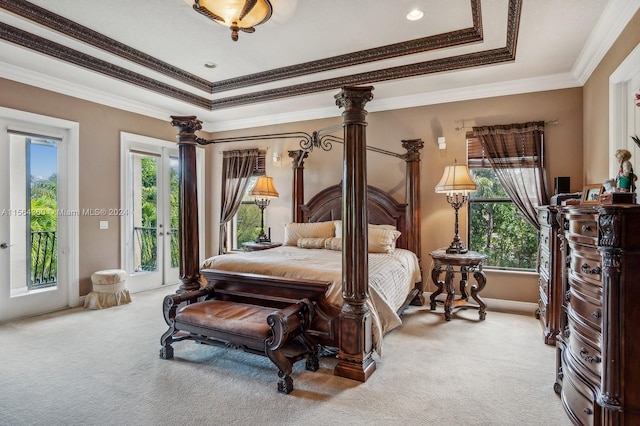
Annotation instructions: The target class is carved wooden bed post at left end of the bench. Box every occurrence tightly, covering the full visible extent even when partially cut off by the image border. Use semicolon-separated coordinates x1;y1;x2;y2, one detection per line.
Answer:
171;115;202;293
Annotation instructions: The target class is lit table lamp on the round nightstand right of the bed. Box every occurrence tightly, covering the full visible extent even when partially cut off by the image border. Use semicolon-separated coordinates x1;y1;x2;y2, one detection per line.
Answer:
436;161;478;253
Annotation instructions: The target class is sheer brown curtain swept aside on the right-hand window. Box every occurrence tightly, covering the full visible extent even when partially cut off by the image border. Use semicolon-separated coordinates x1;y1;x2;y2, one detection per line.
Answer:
469;121;549;230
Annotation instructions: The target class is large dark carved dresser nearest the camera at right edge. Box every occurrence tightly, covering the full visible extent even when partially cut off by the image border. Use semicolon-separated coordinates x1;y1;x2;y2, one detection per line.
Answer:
555;204;640;425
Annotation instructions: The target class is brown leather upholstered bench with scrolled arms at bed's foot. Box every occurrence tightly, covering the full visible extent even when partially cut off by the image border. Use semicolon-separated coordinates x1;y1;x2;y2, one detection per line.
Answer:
160;290;319;394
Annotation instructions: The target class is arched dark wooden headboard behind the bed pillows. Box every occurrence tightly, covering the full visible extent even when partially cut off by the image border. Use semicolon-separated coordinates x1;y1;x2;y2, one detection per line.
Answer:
301;184;411;249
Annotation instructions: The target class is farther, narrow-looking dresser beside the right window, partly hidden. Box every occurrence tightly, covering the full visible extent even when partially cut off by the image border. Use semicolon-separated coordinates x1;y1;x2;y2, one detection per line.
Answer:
536;205;564;345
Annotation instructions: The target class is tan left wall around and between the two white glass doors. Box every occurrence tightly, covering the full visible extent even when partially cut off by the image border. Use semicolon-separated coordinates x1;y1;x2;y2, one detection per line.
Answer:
0;79;176;295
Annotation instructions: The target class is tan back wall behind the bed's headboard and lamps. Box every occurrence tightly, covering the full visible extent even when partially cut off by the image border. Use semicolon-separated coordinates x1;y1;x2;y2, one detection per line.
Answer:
207;88;582;302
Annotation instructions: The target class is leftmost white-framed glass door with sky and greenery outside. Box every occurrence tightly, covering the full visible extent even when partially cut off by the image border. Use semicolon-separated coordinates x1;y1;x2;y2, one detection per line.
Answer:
0;109;79;321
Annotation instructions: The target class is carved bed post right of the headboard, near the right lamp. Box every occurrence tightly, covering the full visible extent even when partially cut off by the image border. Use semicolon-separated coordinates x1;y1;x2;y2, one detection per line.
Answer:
402;139;424;306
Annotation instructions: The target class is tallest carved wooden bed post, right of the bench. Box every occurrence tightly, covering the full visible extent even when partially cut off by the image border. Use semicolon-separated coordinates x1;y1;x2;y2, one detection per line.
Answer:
334;86;376;382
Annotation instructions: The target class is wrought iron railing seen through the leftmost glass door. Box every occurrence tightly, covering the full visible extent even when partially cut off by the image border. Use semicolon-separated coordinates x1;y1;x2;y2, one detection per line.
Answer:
31;231;58;288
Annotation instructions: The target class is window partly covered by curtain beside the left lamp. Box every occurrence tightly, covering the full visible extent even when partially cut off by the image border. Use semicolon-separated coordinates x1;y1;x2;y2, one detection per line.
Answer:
227;151;266;250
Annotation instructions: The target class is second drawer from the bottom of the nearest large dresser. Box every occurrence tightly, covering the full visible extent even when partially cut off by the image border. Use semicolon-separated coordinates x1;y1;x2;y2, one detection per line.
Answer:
565;310;602;378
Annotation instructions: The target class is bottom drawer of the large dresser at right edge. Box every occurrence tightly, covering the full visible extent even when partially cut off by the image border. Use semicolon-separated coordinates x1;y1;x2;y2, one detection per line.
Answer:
562;350;597;425
